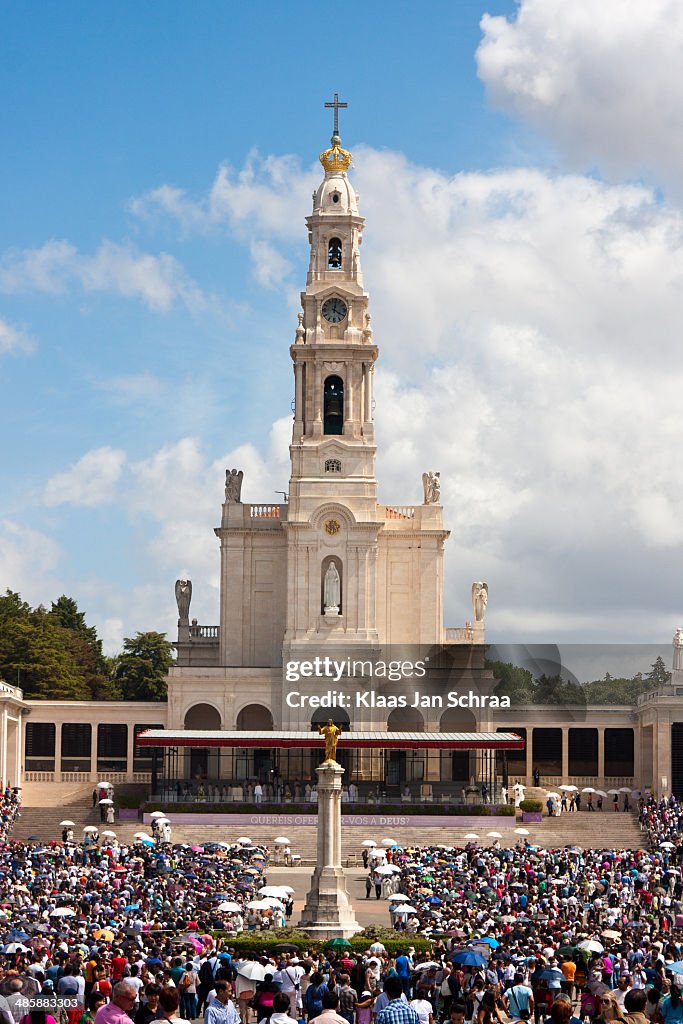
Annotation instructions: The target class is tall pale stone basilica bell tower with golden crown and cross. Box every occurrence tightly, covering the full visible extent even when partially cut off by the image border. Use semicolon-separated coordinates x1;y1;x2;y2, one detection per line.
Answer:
283;108;381;642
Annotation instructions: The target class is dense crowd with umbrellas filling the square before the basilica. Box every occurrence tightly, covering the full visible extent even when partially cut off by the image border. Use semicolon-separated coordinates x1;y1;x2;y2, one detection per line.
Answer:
0;792;683;1024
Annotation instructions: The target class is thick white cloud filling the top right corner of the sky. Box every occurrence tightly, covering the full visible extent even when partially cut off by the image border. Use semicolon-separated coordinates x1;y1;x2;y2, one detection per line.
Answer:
477;0;683;195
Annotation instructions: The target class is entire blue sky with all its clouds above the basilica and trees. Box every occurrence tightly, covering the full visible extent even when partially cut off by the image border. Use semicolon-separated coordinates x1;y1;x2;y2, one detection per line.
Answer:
0;0;683;649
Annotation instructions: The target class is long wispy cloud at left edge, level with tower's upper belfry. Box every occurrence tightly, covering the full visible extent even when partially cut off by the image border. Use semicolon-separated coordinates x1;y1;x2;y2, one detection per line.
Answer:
0;240;206;312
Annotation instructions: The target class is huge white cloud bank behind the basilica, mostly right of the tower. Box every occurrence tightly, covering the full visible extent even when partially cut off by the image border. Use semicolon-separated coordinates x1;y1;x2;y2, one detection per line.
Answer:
28;150;683;640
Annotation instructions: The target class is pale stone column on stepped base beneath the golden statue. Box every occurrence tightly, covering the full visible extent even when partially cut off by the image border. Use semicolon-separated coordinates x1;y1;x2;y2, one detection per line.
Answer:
300;761;360;939
